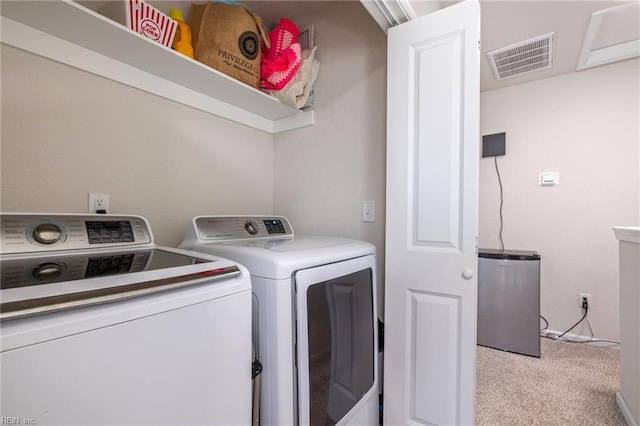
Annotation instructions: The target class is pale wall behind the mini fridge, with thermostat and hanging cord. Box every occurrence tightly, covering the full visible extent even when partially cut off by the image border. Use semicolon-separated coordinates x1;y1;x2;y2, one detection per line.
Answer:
479;59;640;340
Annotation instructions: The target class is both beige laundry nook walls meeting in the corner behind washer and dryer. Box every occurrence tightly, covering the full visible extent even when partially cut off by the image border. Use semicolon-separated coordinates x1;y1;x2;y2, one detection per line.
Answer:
0;2;386;314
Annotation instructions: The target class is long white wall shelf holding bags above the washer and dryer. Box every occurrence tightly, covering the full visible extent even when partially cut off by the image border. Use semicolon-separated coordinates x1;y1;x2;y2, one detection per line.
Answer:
0;0;314;134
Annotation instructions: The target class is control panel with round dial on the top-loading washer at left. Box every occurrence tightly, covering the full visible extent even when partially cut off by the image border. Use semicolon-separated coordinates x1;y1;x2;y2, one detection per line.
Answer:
0;213;153;254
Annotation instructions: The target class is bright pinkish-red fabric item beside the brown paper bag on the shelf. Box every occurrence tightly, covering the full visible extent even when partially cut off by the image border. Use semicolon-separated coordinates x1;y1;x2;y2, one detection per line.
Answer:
260;18;302;90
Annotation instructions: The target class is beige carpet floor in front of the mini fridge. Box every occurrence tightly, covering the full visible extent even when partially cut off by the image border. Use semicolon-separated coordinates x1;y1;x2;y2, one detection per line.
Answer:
476;338;626;426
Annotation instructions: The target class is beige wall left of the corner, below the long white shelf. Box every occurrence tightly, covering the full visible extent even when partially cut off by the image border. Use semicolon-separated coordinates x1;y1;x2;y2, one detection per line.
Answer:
0;45;273;246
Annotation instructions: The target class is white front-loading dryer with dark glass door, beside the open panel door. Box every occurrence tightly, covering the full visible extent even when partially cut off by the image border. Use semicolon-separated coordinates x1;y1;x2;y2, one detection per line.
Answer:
180;216;379;426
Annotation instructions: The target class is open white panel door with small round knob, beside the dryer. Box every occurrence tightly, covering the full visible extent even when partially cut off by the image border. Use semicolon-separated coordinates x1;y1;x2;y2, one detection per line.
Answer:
384;1;480;425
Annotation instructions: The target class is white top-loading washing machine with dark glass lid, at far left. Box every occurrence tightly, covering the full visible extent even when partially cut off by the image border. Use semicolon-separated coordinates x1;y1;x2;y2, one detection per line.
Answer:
0;213;253;425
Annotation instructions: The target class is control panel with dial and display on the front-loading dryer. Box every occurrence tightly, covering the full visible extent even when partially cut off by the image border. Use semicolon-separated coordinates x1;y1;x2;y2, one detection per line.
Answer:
194;216;293;241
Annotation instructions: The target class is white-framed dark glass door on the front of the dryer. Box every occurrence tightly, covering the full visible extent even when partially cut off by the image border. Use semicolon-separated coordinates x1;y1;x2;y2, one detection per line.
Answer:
295;256;378;425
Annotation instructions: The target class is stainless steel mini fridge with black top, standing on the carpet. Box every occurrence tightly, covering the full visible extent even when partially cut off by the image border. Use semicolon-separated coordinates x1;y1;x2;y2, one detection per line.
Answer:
478;249;540;357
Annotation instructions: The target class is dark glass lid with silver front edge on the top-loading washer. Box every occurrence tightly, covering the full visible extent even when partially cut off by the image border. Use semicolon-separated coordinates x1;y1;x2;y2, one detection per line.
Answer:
0;248;242;319
